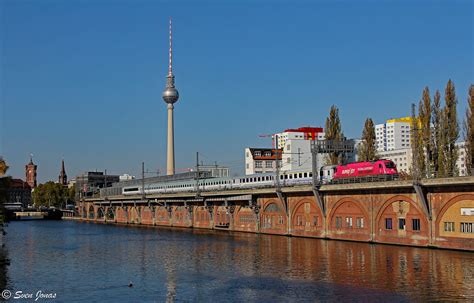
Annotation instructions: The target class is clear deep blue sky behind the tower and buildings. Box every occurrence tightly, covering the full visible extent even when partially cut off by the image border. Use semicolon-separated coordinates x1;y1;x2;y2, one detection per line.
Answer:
0;0;474;182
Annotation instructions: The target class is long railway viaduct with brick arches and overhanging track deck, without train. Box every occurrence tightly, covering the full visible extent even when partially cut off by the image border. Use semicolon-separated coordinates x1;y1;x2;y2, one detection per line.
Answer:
78;177;474;251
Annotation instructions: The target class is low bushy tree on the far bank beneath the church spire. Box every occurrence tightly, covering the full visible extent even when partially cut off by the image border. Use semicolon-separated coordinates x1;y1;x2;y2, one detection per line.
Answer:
33;181;70;208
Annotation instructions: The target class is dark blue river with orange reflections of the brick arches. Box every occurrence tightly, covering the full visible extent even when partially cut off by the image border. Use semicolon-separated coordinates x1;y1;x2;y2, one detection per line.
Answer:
0;221;474;302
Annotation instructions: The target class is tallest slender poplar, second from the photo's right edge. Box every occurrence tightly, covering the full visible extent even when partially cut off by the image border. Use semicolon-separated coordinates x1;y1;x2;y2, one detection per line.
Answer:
444;79;459;175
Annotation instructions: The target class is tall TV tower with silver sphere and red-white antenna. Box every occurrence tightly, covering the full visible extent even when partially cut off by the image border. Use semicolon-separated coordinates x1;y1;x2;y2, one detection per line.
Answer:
163;17;179;175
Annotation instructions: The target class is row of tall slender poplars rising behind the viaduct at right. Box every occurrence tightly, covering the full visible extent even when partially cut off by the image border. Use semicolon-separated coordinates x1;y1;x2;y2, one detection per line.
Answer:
325;80;474;177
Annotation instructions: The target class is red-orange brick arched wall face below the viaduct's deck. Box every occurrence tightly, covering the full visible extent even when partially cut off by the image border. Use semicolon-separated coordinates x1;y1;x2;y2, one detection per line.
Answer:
79;187;474;251
